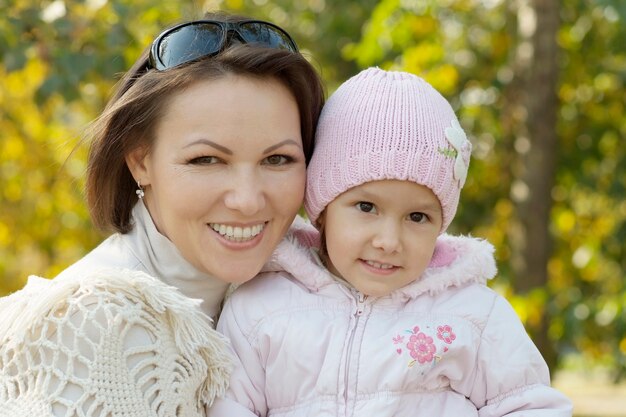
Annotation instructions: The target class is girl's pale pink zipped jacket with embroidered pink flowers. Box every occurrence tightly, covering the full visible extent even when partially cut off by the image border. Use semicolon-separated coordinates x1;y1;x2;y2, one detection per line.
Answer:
209;235;572;417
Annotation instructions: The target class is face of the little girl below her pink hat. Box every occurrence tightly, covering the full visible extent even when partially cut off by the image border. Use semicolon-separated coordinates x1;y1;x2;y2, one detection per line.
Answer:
323;180;442;297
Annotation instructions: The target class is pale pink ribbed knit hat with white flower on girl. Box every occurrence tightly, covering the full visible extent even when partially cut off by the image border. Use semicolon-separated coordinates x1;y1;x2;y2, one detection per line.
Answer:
304;68;471;233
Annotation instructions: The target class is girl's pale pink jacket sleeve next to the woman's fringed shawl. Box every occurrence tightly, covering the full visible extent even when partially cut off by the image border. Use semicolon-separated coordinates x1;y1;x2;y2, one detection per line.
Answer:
208;293;268;417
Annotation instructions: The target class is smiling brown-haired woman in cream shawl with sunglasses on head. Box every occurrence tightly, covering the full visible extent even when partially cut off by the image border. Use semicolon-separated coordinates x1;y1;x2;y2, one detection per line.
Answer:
0;15;323;416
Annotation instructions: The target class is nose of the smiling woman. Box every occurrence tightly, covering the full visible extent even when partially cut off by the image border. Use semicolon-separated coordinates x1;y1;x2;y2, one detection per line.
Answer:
224;171;265;216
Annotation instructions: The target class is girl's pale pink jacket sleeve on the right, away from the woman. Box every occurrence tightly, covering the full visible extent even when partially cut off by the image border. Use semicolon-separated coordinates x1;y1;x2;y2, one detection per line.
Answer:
470;296;572;417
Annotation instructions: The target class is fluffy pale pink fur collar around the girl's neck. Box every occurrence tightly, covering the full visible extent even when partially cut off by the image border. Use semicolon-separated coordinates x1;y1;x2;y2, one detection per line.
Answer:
264;230;497;299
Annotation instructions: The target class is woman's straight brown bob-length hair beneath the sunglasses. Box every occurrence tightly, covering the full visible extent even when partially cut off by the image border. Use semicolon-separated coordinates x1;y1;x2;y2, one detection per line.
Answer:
86;15;324;233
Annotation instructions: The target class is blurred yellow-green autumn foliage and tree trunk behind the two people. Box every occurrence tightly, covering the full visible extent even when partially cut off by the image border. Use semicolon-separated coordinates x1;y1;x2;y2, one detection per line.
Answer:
0;0;626;416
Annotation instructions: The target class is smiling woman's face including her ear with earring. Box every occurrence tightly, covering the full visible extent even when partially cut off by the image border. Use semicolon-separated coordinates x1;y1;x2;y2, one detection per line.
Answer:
127;75;306;283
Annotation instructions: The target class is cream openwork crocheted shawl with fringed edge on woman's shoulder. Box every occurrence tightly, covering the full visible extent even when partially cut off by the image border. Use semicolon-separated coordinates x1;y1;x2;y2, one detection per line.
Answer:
0;270;232;417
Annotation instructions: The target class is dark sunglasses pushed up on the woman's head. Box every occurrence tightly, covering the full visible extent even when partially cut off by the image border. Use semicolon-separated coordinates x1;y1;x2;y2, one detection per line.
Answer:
148;20;298;71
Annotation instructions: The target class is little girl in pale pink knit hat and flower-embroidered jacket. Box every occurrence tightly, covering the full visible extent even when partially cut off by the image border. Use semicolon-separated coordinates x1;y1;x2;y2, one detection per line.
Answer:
209;68;572;417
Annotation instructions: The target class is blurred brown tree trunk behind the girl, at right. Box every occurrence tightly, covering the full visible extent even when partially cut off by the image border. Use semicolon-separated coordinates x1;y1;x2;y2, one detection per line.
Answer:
515;0;560;366
